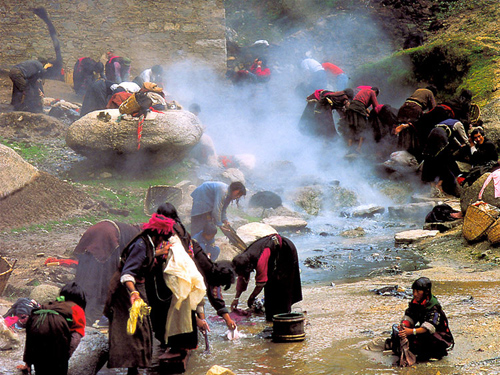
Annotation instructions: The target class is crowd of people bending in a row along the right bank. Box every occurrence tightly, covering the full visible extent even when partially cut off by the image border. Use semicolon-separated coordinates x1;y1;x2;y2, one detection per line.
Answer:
299;79;499;197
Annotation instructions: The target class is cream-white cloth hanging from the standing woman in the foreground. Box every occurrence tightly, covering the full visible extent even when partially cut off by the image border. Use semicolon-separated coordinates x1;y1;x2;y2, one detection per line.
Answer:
163;235;206;342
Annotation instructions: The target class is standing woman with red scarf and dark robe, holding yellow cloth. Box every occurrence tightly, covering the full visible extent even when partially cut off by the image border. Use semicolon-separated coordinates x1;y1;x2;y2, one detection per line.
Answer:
104;214;175;375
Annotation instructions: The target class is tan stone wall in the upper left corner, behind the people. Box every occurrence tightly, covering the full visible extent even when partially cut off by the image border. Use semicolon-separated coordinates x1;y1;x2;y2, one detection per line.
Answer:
0;0;226;76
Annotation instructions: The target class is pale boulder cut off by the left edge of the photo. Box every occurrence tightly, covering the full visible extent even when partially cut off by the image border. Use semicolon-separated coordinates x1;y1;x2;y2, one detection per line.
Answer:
0;144;38;198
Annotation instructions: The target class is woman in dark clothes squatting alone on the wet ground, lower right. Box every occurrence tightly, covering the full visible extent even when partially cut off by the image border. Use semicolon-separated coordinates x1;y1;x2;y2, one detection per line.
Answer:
391;277;455;366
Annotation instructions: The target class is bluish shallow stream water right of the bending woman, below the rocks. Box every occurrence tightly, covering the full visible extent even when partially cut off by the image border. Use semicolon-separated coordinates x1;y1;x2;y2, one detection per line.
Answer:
290;215;428;285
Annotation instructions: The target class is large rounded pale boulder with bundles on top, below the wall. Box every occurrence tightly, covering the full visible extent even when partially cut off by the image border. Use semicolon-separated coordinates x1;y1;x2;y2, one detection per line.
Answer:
66;109;203;163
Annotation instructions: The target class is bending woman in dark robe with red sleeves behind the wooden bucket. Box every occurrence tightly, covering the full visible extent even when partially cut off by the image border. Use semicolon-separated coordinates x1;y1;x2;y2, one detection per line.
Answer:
231;234;302;321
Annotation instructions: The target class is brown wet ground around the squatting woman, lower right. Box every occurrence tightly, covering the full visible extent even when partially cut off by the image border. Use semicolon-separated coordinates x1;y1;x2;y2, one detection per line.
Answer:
90;262;500;375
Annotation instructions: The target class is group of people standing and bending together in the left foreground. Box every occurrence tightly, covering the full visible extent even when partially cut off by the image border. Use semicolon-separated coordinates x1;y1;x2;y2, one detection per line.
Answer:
15;181;302;374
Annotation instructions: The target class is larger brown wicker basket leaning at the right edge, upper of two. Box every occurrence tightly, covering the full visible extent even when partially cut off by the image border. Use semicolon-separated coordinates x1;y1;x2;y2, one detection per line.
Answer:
462;201;500;241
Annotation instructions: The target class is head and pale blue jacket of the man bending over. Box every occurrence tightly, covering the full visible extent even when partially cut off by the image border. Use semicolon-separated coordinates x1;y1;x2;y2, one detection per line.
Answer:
191;181;247;234
